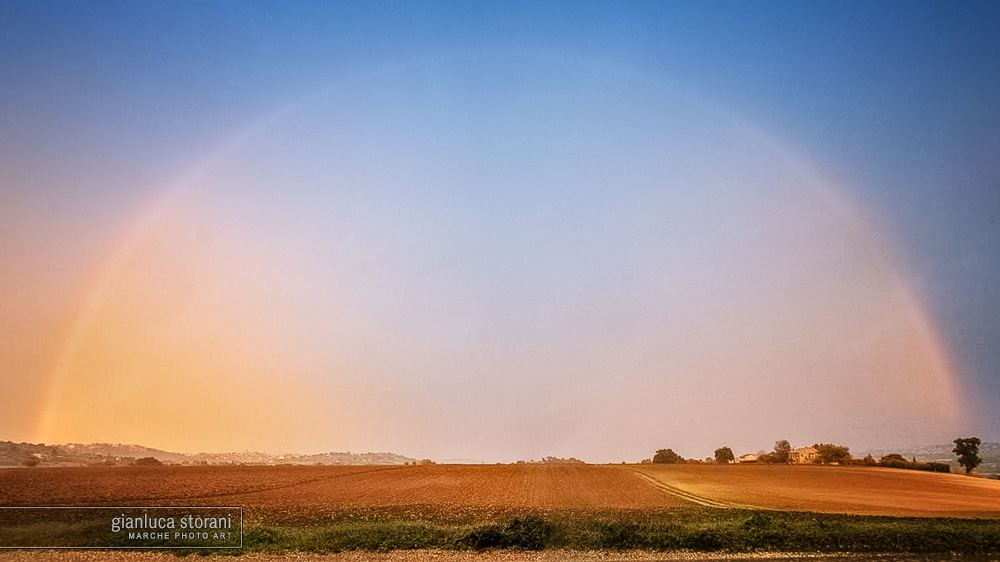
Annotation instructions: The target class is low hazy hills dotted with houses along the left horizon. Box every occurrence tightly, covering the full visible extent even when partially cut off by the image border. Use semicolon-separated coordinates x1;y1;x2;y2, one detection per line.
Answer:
0;441;416;467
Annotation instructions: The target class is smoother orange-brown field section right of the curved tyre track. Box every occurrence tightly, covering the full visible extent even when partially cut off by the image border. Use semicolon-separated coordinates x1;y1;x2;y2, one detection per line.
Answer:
633;465;1000;519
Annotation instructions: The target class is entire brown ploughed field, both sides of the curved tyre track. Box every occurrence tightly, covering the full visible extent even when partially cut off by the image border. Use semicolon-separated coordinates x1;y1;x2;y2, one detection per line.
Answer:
0;464;1000;518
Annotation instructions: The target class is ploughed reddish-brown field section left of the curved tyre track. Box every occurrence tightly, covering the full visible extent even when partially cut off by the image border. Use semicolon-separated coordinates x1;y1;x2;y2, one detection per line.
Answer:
0;464;689;515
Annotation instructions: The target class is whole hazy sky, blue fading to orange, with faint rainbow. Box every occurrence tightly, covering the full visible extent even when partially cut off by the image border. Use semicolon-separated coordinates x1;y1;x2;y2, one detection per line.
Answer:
0;1;1000;461
